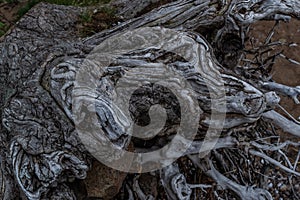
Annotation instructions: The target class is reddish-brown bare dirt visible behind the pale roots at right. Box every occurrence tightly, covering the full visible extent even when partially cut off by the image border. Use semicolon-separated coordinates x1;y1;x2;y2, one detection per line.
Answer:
249;19;300;139
